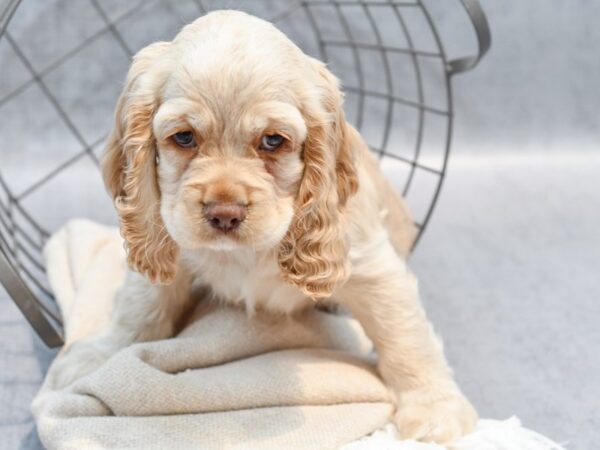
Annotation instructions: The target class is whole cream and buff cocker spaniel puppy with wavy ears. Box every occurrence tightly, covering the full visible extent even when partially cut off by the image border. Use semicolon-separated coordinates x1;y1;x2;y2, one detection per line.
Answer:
59;11;477;443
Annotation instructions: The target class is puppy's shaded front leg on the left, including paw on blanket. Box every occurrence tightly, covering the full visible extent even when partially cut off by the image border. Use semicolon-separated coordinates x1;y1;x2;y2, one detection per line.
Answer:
51;271;190;388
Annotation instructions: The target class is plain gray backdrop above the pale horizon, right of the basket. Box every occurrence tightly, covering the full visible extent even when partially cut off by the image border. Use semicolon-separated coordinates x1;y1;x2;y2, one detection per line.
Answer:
428;0;600;153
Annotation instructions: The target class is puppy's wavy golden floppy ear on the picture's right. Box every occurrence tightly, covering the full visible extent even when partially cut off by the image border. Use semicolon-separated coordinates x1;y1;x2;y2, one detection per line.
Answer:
279;59;358;299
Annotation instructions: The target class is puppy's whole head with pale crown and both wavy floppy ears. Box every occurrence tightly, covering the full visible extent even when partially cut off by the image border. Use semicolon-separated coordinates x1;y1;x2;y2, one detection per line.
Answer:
103;12;357;297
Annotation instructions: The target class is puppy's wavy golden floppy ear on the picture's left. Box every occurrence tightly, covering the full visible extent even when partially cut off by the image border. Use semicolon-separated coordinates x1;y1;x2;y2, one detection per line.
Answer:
102;42;179;283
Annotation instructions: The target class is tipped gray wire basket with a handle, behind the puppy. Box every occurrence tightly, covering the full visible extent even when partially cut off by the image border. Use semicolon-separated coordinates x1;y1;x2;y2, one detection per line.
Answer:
0;0;490;347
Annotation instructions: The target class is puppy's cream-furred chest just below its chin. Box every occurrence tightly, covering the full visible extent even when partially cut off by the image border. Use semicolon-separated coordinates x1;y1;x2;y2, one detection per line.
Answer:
188;252;311;314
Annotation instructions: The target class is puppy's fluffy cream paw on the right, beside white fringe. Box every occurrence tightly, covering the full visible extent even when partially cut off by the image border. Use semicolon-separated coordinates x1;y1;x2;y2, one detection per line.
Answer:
395;387;477;445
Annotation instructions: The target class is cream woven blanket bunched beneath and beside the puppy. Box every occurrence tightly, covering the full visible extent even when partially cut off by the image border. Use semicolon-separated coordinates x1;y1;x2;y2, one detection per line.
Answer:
33;221;558;450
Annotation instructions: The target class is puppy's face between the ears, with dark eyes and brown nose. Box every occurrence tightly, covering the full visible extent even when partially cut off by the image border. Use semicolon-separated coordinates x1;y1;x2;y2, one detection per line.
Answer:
152;80;307;250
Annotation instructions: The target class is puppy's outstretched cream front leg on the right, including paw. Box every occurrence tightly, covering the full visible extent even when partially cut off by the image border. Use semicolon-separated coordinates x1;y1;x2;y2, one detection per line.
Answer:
336;240;477;444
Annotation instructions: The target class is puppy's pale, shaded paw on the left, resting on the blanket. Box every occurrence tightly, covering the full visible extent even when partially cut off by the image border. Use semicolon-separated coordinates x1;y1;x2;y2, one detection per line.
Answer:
50;340;111;389
